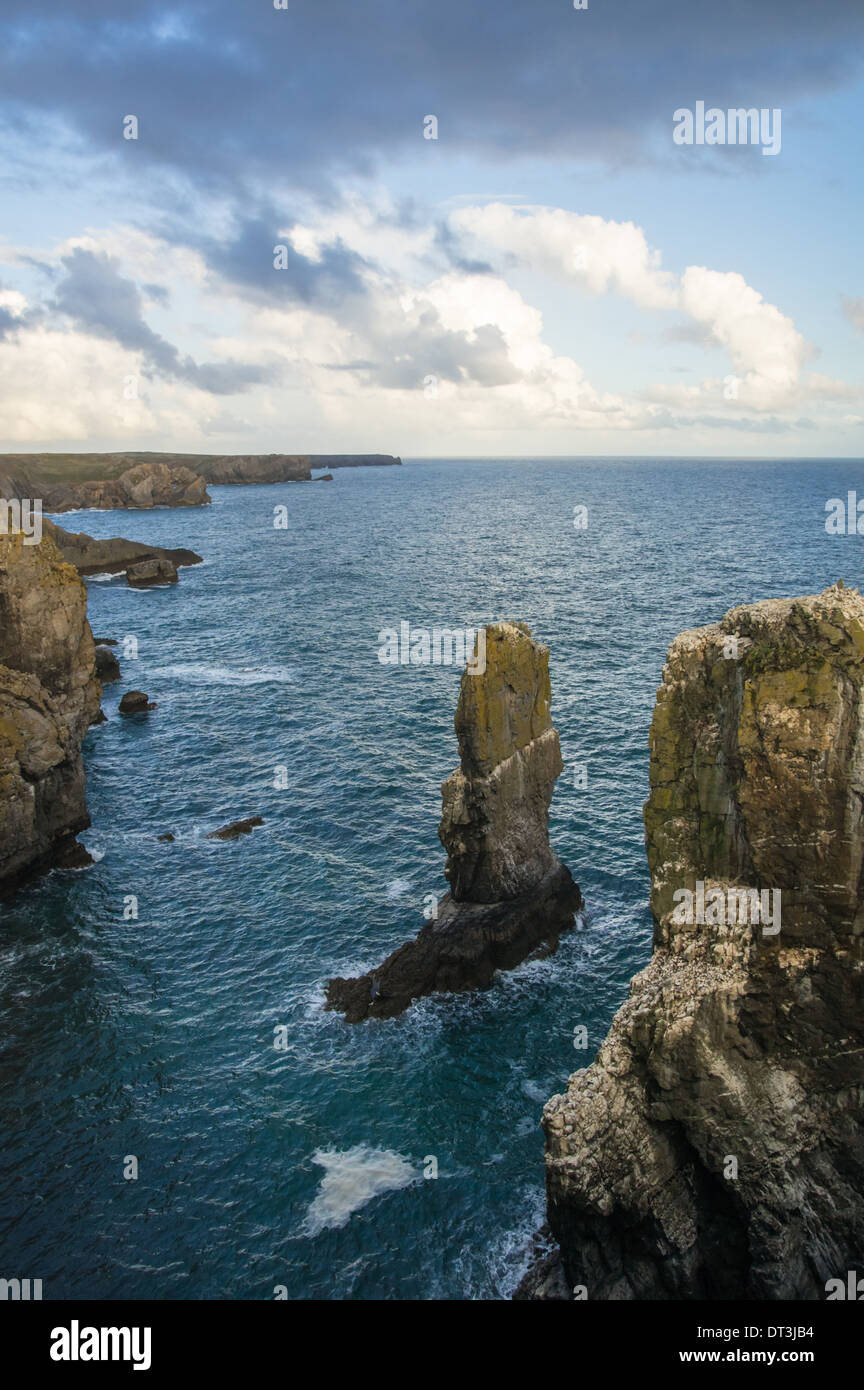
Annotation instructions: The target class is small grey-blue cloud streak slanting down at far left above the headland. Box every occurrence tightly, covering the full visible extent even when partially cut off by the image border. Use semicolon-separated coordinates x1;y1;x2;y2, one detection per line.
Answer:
51;247;269;396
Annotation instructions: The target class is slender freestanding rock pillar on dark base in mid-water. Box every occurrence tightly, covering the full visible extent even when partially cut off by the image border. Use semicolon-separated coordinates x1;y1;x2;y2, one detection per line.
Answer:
326;623;582;1023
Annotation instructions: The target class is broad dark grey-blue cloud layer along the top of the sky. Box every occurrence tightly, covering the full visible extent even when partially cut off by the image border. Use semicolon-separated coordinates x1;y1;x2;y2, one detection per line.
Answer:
0;0;864;197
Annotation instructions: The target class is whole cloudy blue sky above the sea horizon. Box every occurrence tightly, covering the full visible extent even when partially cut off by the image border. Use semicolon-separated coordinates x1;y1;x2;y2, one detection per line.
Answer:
0;0;864;459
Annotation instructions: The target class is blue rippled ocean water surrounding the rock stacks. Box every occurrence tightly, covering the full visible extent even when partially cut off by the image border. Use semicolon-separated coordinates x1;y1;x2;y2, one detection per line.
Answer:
0;460;861;1300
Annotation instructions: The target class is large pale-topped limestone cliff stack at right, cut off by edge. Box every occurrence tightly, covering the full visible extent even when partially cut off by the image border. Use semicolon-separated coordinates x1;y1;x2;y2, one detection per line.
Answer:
517;585;864;1300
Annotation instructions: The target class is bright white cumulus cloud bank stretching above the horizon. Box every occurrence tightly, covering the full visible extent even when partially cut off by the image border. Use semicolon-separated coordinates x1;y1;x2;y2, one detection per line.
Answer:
0;211;861;453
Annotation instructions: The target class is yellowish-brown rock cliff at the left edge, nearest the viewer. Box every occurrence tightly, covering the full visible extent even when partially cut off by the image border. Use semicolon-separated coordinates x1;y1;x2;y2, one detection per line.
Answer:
0;535;101;892
